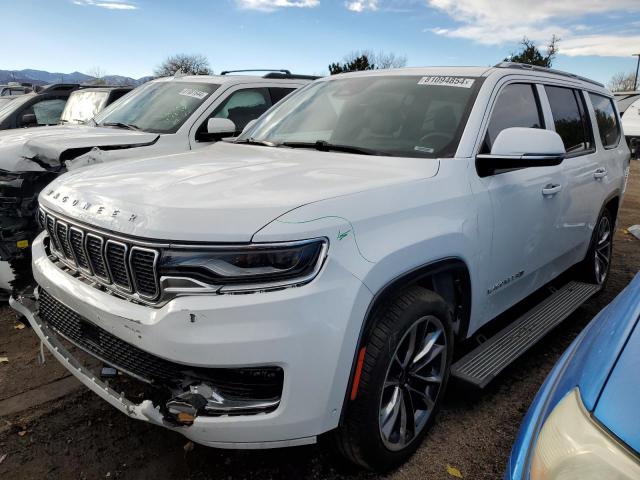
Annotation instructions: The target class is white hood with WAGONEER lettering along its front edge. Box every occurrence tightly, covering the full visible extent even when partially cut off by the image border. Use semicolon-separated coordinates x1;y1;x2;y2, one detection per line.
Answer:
40;142;439;242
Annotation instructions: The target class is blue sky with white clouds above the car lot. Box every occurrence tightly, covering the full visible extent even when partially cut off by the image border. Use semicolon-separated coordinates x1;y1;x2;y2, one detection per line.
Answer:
0;0;640;83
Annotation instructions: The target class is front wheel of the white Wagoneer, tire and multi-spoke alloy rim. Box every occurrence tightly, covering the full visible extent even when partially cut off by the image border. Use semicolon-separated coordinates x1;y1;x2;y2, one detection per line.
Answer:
336;286;453;471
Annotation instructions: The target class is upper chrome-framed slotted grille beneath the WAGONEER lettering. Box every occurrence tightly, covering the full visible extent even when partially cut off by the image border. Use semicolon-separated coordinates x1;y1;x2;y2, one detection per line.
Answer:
38;209;160;302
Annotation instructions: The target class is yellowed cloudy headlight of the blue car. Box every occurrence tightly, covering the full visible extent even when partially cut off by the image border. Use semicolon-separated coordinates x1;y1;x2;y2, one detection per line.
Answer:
530;388;640;480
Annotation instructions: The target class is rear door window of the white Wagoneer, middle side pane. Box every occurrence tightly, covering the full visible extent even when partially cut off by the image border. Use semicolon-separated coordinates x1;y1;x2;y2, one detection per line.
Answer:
544;86;594;154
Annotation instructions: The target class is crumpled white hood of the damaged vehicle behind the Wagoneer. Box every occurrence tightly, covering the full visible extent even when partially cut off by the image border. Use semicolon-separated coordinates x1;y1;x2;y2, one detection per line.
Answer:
0;125;159;172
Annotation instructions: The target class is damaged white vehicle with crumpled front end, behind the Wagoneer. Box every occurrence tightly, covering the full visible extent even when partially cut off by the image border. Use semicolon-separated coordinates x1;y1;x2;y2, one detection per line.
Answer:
0;70;314;294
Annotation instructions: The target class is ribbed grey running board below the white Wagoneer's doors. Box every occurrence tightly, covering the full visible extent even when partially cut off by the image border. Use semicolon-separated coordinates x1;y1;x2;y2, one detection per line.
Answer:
451;281;600;388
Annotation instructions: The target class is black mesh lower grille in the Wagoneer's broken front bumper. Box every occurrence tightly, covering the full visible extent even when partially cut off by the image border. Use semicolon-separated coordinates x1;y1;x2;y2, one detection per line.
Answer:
38;289;284;400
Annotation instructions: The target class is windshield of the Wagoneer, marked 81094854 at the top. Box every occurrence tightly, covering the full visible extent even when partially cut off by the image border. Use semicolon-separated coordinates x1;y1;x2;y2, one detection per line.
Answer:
238;75;480;158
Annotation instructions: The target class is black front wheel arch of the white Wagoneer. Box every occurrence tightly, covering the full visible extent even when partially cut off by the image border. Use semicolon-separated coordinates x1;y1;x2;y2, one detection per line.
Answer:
340;257;472;424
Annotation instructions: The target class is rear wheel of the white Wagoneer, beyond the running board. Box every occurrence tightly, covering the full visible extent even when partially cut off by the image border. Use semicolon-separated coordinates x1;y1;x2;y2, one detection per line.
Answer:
578;208;615;288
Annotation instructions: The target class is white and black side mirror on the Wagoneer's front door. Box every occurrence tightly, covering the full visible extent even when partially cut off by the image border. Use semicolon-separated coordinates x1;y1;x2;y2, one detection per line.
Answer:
476;127;566;177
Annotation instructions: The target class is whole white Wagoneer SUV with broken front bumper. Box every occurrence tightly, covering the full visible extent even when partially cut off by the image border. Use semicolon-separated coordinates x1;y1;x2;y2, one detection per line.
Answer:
11;63;629;470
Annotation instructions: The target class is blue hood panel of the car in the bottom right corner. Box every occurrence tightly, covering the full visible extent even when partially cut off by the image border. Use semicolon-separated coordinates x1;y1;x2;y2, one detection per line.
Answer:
594;312;640;452
